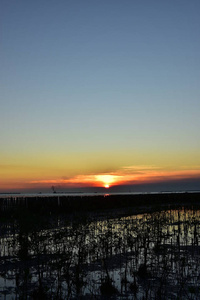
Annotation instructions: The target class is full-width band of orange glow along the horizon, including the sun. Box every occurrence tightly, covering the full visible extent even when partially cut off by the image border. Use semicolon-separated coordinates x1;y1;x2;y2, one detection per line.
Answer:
1;166;200;191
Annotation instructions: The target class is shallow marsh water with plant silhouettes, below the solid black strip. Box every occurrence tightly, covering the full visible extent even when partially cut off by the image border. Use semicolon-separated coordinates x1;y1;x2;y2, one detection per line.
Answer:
0;208;200;299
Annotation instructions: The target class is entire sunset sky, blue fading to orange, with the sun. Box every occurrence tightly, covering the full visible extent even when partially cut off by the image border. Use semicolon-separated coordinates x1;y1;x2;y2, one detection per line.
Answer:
0;0;200;192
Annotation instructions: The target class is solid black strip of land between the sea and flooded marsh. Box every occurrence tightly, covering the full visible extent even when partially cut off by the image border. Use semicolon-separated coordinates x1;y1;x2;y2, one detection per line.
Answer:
0;191;200;215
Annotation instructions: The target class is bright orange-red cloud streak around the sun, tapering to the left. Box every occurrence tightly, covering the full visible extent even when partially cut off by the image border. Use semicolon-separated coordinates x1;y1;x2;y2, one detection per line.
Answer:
29;166;200;187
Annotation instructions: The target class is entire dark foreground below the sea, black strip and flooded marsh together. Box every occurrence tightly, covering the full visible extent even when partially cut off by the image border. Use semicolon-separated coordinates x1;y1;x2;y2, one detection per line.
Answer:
0;193;200;299
